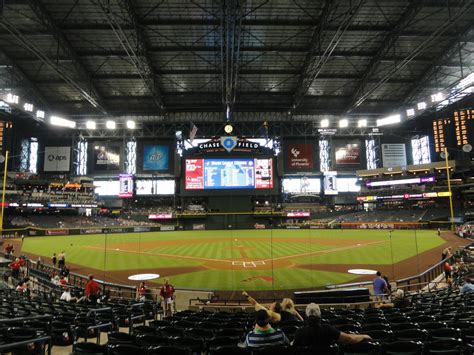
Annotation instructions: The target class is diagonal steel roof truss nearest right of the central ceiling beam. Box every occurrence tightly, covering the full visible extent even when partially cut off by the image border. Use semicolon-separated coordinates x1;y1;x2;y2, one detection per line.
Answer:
290;0;363;111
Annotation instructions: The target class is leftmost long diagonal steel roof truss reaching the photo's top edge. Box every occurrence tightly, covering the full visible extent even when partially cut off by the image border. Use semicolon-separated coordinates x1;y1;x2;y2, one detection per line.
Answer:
29;0;106;113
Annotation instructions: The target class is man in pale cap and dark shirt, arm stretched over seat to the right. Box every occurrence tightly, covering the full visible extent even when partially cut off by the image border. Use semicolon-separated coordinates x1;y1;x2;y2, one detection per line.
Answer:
293;303;372;354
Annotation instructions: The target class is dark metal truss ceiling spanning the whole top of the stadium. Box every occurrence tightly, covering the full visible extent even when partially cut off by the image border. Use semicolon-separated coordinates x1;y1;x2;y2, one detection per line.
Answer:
0;0;474;121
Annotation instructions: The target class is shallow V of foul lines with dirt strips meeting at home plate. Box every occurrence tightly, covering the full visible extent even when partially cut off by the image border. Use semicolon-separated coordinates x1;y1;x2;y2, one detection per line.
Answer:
85;240;387;263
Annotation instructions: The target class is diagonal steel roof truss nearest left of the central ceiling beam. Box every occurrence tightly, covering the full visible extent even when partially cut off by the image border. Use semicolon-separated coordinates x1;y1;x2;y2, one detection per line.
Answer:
92;0;165;113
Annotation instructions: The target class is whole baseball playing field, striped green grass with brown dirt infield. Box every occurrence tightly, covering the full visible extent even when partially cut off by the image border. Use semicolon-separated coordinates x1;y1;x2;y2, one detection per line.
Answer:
22;229;444;290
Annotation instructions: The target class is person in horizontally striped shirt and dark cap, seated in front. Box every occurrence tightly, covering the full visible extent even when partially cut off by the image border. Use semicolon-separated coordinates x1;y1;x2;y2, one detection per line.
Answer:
244;309;289;348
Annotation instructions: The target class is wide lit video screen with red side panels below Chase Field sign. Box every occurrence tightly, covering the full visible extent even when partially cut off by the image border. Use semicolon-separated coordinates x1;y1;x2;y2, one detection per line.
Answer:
185;158;273;190
